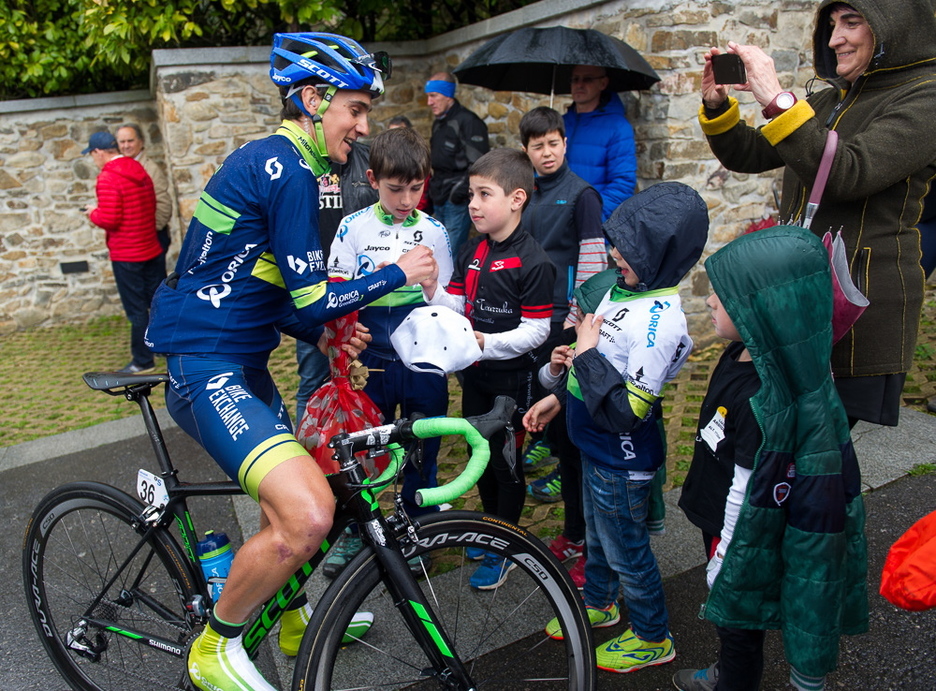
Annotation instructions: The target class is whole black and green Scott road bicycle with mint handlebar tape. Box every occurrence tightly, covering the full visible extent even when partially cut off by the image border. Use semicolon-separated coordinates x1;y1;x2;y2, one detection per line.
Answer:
23;372;595;691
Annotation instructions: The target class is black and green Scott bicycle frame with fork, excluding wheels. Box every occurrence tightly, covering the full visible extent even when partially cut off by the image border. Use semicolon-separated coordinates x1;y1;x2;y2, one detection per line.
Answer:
85;379;471;687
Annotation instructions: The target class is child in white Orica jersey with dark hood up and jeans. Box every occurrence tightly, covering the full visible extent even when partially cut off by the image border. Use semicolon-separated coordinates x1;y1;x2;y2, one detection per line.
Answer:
524;182;708;672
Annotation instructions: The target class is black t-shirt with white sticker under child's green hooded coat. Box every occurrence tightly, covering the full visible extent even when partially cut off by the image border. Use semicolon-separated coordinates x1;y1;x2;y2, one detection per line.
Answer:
679;342;763;537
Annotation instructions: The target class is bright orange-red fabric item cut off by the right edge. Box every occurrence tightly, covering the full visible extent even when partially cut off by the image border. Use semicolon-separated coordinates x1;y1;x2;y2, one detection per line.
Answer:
881;511;936;612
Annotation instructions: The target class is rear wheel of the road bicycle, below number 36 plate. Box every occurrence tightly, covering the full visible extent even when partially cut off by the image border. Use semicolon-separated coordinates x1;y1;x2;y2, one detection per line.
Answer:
23;482;196;691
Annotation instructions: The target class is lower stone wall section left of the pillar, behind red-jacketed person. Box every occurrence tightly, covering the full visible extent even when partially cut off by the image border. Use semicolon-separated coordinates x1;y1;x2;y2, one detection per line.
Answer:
0;96;176;334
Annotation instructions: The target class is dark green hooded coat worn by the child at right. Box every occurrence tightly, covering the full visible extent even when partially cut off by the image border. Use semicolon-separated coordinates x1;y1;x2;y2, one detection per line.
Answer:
705;226;868;676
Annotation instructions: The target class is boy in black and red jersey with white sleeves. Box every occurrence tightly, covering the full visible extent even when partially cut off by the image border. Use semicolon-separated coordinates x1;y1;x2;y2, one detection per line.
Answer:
422;149;556;590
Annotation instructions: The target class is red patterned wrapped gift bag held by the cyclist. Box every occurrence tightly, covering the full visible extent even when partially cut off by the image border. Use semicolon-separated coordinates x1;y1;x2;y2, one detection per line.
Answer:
296;312;389;475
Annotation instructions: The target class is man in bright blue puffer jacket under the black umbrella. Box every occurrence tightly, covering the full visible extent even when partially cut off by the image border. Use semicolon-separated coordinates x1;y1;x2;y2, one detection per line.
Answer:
562;65;637;221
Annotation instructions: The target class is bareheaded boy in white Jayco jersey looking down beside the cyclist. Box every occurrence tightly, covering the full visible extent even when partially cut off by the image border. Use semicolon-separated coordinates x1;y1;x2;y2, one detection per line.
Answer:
323;127;452;577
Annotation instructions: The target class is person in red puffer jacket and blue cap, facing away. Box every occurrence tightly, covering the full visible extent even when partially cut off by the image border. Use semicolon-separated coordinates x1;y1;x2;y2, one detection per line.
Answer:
81;132;166;372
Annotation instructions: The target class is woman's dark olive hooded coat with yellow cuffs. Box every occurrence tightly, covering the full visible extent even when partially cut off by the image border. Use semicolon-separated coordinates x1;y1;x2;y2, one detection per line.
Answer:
699;0;936;377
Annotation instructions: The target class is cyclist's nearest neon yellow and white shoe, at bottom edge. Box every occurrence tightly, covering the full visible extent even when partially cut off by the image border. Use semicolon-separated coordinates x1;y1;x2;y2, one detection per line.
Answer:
188;626;276;691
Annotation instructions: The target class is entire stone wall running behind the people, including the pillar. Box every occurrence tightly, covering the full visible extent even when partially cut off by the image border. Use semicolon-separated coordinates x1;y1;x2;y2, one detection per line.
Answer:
0;0;815;342
